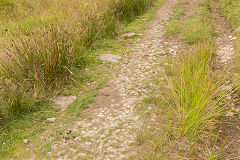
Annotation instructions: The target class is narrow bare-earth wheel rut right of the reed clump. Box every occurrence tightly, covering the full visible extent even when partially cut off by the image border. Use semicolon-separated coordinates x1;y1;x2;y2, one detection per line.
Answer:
213;4;240;160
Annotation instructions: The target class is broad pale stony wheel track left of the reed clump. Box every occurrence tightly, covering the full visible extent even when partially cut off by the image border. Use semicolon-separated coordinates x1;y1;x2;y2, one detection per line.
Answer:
43;0;178;160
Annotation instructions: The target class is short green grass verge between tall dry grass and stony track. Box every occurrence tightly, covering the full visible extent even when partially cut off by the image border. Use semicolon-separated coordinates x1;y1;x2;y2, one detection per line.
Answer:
0;0;167;159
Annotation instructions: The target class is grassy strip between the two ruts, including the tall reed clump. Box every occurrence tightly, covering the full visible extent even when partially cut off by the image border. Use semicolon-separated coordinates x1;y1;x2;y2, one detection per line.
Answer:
138;0;234;160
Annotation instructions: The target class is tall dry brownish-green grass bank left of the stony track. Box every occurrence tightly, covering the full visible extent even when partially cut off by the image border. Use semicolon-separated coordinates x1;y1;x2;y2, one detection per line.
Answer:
0;0;154;116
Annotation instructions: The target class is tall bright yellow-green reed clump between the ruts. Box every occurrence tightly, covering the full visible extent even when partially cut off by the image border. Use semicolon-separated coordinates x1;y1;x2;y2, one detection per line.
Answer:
169;42;231;140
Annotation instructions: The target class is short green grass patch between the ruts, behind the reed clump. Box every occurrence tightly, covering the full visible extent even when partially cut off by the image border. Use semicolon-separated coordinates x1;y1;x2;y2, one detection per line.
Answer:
166;1;215;44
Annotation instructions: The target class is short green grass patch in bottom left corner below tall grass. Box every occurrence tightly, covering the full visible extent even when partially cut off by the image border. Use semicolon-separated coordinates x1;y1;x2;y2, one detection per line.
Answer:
0;106;59;159
